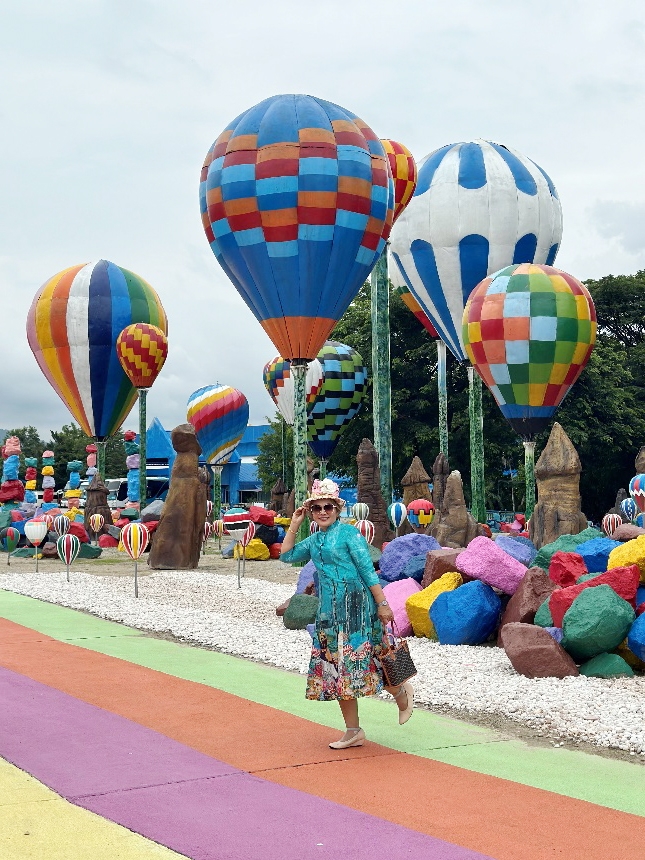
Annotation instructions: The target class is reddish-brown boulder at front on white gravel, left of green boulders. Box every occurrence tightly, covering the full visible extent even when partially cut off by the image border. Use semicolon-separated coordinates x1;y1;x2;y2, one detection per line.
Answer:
502;622;578;678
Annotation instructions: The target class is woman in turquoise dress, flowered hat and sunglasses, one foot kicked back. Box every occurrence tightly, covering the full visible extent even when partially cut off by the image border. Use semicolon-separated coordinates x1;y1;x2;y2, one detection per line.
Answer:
280;479;414;749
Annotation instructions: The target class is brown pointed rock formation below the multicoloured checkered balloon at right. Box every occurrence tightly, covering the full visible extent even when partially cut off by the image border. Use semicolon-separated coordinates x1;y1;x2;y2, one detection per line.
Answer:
529;421;587;549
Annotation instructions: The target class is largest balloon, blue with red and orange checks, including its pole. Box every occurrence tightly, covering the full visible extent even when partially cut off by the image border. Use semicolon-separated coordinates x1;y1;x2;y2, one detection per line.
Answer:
200;95;394;520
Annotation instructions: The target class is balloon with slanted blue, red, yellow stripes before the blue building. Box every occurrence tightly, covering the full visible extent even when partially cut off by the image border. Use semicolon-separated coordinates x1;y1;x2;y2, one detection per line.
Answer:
186;383;249;519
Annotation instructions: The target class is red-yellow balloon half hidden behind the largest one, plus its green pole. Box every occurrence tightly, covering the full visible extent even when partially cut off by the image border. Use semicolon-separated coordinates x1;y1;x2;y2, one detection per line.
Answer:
370;139;417;502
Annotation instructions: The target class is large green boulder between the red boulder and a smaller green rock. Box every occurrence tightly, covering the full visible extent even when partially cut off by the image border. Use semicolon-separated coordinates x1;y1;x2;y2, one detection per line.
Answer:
562;585;636;663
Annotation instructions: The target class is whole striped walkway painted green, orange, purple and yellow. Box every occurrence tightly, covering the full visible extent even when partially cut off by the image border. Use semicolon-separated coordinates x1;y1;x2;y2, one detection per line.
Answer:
0;591;645;860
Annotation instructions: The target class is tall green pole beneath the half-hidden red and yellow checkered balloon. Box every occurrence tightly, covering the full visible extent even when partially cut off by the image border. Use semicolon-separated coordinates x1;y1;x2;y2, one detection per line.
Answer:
370;245;392;505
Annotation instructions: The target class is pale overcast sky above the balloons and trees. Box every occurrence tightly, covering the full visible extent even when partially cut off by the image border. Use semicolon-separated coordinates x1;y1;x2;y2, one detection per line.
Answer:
0;0;645;440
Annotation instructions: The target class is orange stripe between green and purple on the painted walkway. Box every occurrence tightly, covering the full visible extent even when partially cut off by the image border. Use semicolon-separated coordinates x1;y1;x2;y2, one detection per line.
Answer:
0;620;645;860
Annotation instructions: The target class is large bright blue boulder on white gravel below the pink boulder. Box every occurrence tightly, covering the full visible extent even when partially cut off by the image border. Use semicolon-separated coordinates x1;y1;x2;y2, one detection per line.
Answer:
430;581;502;645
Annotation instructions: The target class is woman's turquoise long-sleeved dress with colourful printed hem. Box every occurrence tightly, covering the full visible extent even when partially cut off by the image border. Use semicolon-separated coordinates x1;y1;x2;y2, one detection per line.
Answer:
282;521;383;702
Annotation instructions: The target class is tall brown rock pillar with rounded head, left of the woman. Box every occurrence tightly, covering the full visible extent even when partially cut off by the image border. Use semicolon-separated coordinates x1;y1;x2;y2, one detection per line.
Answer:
148;424;206;570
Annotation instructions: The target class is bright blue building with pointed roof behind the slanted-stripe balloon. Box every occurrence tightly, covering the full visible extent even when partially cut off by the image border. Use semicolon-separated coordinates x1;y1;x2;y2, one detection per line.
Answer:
146;418;270;505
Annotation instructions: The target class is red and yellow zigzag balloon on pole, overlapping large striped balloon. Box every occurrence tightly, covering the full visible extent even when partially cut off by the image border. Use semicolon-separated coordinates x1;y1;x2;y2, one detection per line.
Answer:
116;322;168;510
